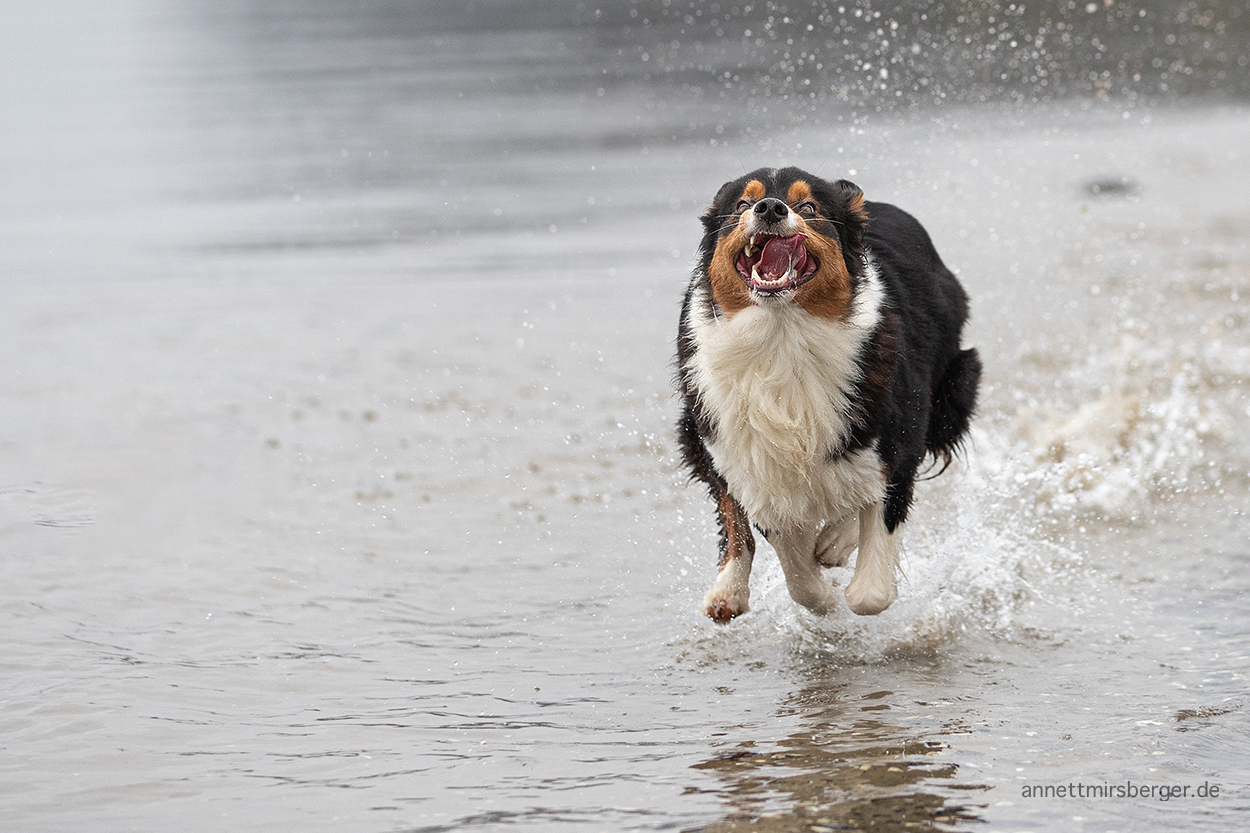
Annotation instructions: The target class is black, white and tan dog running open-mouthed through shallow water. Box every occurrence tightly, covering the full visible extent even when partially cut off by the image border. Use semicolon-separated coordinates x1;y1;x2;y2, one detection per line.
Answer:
676;168;981;623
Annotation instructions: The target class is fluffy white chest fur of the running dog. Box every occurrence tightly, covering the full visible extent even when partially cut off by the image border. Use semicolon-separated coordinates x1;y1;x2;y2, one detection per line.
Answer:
689;263;884;529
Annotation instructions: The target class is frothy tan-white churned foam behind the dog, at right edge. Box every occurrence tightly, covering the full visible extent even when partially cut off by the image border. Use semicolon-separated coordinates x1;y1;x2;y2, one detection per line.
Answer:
1016;322;1250;524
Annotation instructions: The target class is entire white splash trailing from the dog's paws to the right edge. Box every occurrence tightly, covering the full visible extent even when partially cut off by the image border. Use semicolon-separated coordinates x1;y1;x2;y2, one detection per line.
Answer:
685;318;1250;663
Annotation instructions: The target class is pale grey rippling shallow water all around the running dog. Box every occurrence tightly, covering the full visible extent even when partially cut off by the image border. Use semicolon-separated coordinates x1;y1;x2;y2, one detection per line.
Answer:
0;4;1250;830
